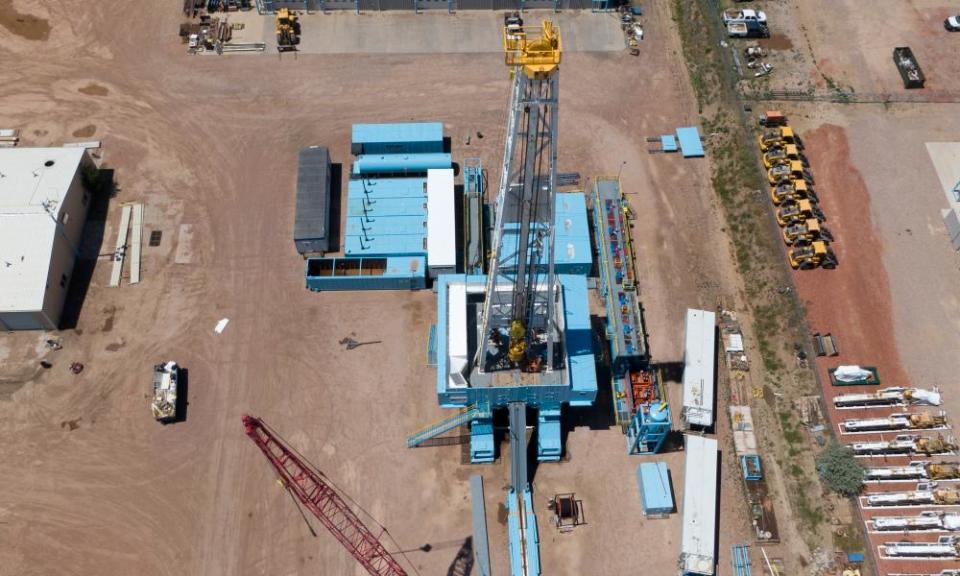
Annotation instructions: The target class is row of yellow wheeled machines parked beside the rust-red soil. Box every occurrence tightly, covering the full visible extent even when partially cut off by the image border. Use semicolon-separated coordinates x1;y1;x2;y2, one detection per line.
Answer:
757;121;837;270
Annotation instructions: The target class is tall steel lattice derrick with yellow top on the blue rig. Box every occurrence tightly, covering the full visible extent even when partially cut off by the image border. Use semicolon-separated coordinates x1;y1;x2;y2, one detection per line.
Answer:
475;15;562;374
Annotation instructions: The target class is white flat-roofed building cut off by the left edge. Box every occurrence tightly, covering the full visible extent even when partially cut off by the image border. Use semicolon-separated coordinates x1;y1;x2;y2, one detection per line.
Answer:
0;148;90;330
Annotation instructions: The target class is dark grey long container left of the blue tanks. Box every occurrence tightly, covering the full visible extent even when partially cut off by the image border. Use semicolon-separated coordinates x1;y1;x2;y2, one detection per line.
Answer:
293;146;330;240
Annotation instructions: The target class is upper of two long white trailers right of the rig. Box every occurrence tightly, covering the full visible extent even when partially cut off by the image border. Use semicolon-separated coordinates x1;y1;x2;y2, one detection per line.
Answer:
683;309;717;427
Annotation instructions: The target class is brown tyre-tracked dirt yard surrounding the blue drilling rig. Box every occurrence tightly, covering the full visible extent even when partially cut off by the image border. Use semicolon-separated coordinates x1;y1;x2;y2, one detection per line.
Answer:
0;0;772;575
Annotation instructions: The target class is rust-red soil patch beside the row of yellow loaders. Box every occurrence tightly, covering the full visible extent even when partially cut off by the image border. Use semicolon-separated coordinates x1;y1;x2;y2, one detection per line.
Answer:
796;125;910;396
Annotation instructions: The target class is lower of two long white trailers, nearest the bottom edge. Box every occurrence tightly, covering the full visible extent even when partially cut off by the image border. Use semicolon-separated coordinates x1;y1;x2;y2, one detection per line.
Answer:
680;434;717;576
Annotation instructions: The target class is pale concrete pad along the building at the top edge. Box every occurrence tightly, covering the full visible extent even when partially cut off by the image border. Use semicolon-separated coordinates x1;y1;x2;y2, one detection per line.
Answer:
262;11;624;54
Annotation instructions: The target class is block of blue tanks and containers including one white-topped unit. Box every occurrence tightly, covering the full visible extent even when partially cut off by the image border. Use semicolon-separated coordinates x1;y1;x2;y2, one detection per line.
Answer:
306;122;456;291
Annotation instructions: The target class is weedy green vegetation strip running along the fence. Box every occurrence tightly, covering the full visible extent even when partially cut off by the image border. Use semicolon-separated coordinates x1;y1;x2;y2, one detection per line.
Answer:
672;0;825;549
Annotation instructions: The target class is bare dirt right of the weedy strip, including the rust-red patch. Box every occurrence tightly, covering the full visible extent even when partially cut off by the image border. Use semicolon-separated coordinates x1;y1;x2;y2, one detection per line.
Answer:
764;2;960;574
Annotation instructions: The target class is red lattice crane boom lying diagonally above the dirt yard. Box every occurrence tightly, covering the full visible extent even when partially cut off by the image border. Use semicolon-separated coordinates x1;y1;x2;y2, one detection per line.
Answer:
243;415;407;576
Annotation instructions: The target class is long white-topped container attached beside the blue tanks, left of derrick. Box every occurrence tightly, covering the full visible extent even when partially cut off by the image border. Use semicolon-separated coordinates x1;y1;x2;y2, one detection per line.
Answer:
427;168;457;268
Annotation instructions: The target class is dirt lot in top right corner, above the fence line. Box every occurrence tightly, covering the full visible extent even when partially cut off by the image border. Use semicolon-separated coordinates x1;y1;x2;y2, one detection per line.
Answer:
733;0;960;101
